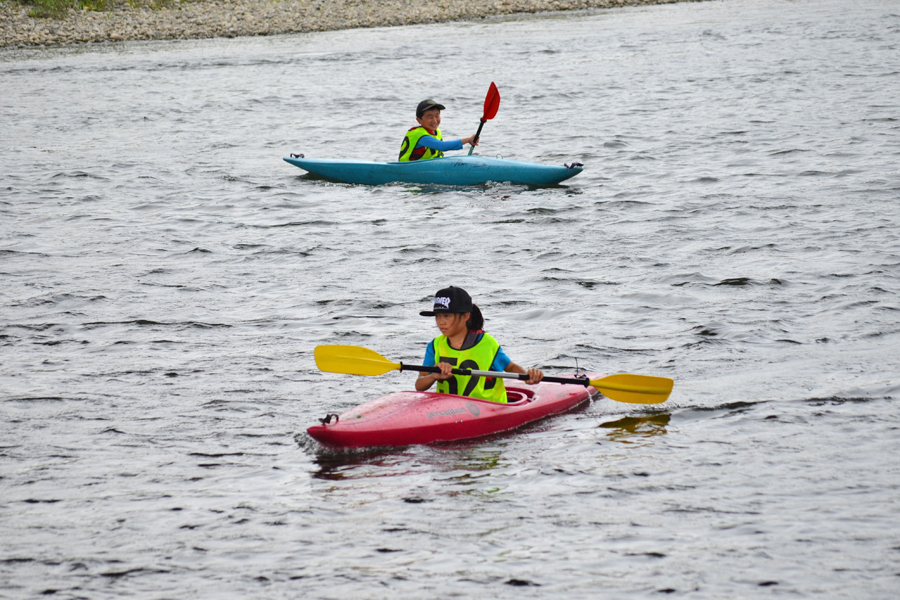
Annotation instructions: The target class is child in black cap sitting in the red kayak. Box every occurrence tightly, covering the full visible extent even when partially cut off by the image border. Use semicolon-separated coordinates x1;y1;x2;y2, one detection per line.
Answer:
416;286;544;404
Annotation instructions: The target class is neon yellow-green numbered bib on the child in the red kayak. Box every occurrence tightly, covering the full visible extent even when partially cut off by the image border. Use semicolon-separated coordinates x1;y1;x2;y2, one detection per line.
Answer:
434;333;506;404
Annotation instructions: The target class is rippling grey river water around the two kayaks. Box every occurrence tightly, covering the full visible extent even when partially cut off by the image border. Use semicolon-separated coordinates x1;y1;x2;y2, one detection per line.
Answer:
0;0;900;599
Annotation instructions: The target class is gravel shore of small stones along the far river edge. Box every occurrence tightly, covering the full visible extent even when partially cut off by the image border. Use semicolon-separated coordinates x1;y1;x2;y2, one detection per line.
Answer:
0;0;697;47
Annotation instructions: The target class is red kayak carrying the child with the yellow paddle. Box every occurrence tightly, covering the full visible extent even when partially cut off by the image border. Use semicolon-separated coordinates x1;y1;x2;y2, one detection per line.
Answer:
307;375;600;448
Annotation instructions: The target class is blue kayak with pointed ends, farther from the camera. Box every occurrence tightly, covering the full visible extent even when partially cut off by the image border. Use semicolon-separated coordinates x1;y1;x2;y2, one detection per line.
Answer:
284;154;582;185
